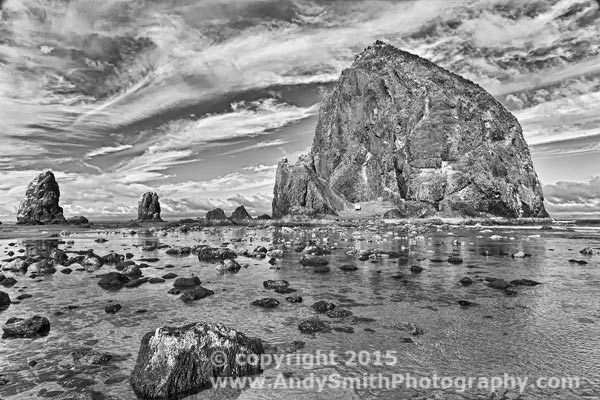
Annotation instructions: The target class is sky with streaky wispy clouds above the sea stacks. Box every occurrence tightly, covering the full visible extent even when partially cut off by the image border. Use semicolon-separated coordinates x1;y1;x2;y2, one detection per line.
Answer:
0;0;600;222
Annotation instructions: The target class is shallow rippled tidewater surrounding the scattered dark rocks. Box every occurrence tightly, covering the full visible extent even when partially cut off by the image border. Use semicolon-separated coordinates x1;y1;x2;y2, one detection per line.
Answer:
0;225;600;400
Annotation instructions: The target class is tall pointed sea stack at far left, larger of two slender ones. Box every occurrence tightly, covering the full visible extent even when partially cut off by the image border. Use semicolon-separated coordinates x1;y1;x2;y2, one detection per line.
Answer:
17;171;66;225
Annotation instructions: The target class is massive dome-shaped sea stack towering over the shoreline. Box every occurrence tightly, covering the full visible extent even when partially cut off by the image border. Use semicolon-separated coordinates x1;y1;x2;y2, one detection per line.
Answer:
273;41;548;218
